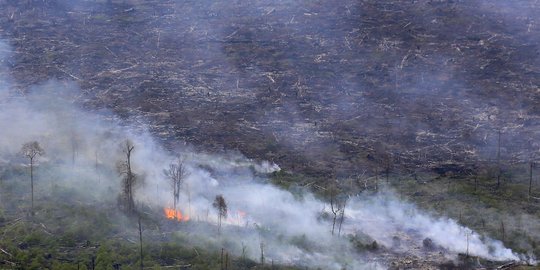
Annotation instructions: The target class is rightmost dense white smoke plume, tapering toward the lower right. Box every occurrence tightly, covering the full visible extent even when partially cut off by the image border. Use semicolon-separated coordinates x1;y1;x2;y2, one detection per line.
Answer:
348;192;519;261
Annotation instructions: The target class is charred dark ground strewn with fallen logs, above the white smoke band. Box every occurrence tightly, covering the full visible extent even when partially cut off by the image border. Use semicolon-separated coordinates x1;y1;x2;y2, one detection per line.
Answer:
0;0;540;174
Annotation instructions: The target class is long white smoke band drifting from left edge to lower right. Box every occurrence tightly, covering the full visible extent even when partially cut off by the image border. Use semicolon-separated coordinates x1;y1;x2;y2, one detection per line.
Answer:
0;37;532;269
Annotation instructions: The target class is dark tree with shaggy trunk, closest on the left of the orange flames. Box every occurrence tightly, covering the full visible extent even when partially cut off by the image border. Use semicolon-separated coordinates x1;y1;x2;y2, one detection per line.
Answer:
117;140;137;212
